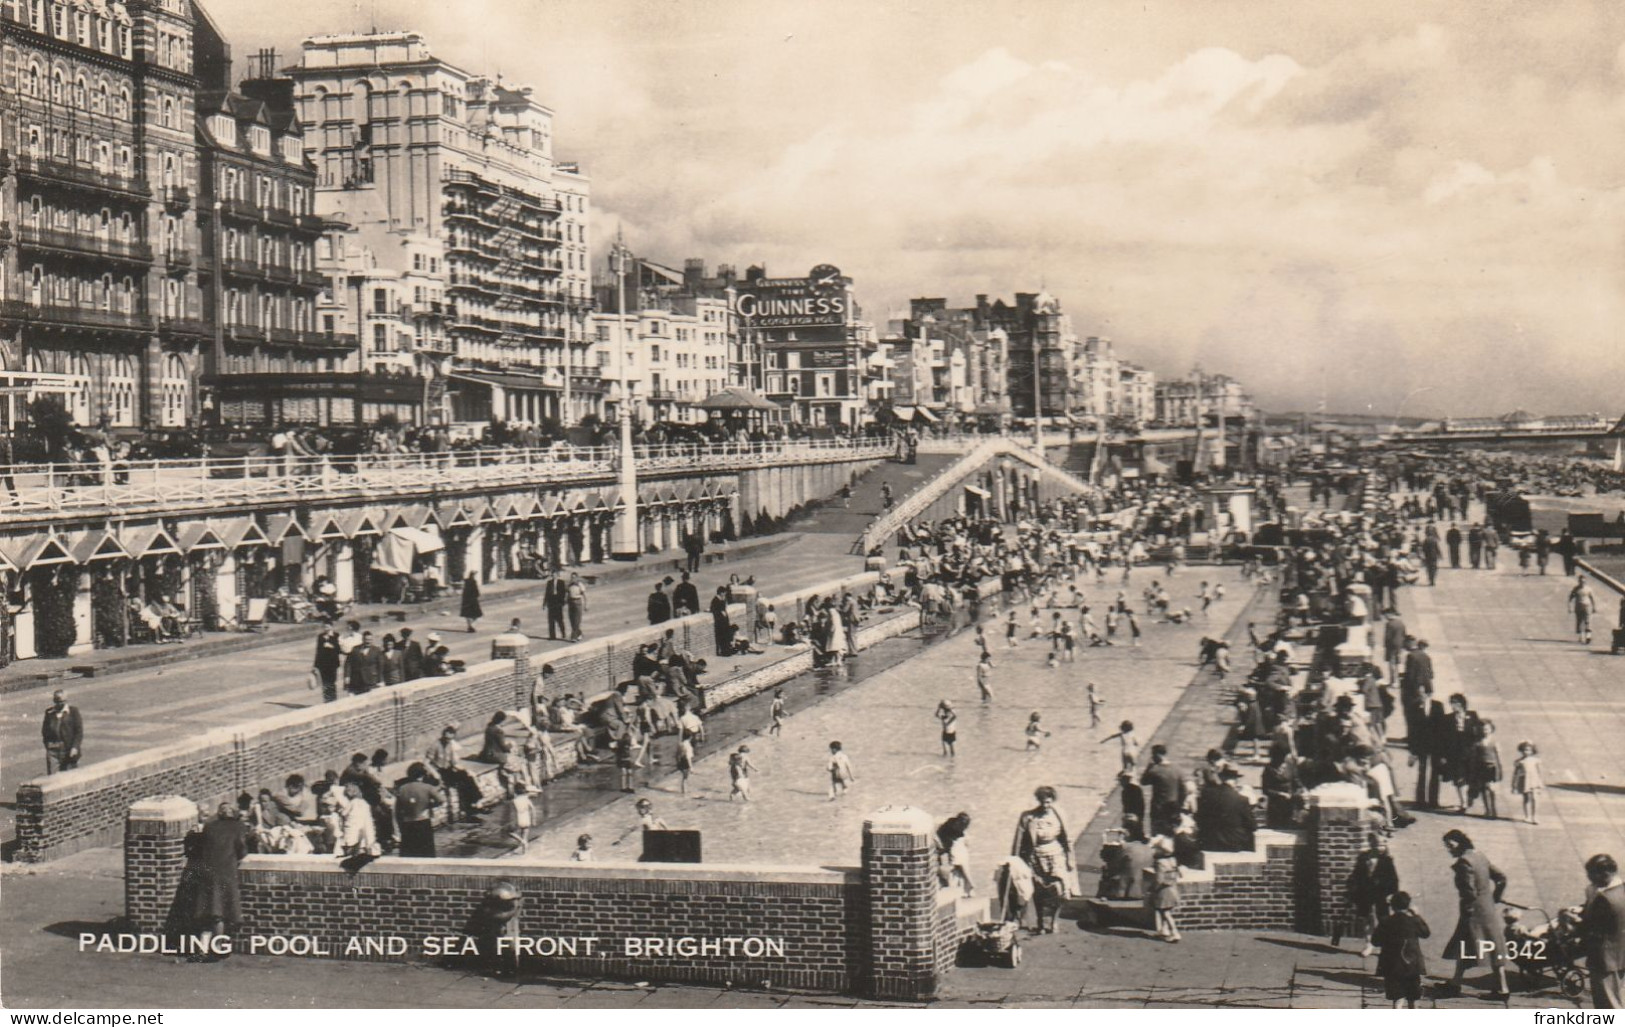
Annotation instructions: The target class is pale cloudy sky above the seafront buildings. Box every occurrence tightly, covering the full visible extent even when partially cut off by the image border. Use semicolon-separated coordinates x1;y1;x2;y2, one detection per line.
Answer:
203;0;1625;416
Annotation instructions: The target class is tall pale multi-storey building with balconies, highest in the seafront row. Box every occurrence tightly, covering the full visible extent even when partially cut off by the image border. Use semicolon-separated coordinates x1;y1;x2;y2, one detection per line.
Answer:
289;33;593;423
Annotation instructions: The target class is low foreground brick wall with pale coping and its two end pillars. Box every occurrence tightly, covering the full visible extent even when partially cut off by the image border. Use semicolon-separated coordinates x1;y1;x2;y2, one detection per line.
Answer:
125;796;973;999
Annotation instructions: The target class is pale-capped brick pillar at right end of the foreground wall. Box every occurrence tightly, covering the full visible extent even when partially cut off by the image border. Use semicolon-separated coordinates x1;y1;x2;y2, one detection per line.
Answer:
863;806;938;999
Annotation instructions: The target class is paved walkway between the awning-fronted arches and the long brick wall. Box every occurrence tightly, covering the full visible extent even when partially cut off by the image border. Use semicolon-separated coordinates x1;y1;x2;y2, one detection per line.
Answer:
0;535;863;837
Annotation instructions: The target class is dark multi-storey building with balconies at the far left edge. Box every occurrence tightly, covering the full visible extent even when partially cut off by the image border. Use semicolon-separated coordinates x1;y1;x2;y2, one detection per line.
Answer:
0;0;200;427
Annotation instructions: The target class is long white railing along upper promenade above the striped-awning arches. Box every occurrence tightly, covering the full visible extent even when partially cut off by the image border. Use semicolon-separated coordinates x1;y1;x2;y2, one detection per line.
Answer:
0;439;892;515
